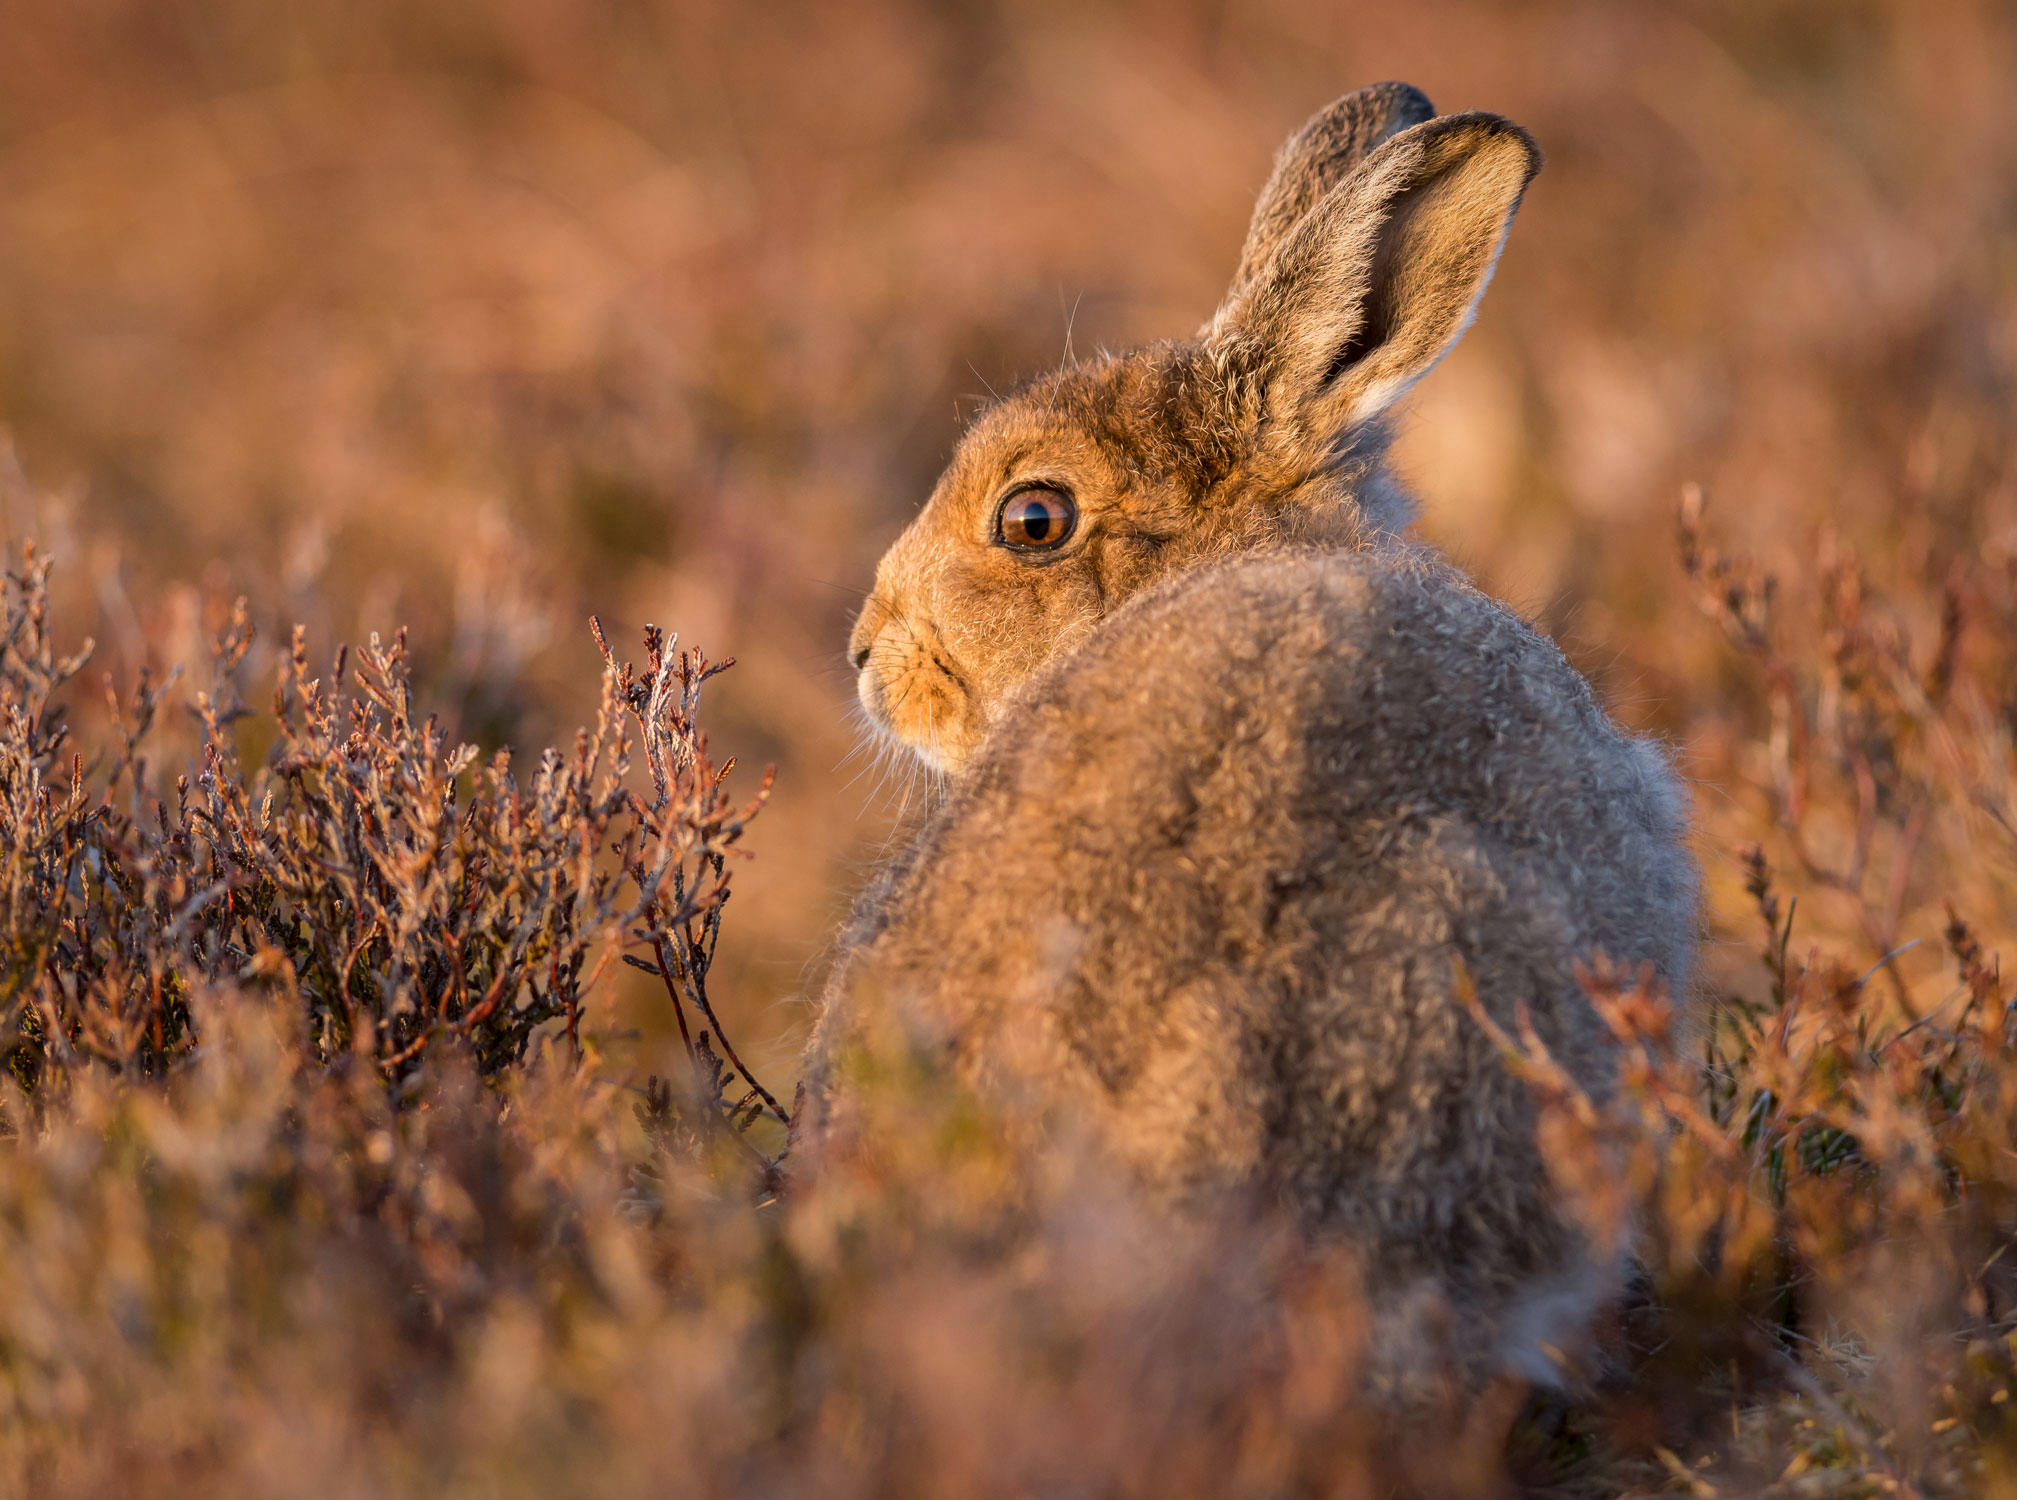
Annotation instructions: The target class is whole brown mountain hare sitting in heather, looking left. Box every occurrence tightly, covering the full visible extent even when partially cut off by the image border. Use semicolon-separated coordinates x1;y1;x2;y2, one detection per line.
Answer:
801;85;1696;1377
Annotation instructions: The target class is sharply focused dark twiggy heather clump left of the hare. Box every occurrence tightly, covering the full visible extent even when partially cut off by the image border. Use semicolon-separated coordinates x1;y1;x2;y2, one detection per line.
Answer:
0;544;789;1133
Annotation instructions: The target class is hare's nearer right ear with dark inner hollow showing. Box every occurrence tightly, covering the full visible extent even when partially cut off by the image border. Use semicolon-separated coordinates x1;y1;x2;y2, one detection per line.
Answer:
1204;115;1541;450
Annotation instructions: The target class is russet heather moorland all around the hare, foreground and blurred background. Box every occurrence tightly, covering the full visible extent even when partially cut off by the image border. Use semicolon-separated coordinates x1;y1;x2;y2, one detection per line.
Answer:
0;0;2017;1498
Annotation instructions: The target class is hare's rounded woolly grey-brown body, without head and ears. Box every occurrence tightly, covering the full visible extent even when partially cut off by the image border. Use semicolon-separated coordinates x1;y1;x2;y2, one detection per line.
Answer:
823;554;1692;1338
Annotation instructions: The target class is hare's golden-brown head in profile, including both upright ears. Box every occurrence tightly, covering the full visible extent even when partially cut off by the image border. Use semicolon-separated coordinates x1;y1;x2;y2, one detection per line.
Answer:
849;83;1539;770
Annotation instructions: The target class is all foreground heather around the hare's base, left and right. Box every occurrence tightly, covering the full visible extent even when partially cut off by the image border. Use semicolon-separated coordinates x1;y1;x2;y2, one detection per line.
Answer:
0;494;2017;1496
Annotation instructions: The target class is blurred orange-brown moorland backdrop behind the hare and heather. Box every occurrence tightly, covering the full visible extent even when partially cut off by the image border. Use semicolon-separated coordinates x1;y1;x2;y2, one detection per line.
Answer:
0;0;2017;1077
